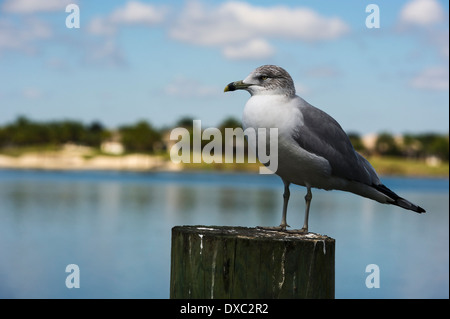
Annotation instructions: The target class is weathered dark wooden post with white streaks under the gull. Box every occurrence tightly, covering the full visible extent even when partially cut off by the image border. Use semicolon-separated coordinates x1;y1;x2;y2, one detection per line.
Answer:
170;226;335;299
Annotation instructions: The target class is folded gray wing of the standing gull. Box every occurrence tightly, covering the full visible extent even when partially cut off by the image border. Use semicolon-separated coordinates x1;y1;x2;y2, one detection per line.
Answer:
294;101;380;185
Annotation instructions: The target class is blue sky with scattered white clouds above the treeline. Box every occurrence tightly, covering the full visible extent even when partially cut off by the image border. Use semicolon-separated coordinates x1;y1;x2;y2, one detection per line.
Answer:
0;0;449;134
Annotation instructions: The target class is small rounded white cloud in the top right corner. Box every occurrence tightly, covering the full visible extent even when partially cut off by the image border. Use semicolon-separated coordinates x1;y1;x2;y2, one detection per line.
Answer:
400;0;444;27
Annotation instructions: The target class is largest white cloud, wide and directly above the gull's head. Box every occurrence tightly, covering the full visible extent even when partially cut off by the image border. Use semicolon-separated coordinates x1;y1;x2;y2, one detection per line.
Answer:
169;1;350;58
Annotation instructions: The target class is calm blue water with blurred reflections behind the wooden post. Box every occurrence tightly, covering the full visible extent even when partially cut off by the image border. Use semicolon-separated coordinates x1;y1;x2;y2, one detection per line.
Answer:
0;170;449;298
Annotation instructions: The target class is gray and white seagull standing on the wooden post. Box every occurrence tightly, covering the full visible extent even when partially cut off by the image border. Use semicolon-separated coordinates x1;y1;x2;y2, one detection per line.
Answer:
224;65;425;233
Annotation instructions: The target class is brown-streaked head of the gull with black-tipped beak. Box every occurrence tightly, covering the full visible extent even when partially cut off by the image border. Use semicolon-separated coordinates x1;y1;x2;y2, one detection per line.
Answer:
224;65;295;96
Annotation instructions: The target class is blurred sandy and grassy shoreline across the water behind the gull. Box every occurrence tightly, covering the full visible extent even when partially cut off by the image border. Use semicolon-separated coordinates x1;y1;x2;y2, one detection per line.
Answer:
0;151;449;179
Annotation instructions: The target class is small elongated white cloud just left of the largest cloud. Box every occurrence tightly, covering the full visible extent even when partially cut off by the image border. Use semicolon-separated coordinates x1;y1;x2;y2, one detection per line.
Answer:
88;1;167;35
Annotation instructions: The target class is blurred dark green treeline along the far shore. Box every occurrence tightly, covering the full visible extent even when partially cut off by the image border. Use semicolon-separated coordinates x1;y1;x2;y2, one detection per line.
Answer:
0;116;449;161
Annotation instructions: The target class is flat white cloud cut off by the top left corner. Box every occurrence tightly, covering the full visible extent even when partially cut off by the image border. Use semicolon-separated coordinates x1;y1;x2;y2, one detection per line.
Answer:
2;0;77;14
